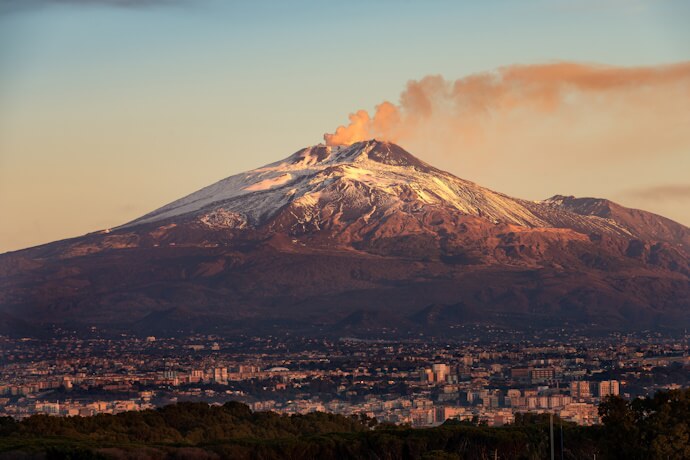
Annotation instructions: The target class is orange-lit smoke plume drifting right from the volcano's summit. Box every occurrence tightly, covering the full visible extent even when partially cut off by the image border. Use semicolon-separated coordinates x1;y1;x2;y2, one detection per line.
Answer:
324;62;690;172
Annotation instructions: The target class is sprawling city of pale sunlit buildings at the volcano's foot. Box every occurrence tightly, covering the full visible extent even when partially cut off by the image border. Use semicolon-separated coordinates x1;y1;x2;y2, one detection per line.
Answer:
0;326;690;427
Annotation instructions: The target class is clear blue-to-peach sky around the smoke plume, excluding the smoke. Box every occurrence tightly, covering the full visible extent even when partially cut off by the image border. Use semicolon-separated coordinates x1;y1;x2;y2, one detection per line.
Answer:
0;0;690;251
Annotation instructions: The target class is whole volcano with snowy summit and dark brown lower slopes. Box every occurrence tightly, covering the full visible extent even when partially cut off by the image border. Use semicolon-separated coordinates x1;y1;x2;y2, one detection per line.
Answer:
0;140;690;334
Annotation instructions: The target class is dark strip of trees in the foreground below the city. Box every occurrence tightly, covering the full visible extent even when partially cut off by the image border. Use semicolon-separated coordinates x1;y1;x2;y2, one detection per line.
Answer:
0;389;690;460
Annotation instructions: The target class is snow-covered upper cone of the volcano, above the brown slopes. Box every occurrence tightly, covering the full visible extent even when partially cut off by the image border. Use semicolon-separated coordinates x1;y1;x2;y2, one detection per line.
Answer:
128;140;546;226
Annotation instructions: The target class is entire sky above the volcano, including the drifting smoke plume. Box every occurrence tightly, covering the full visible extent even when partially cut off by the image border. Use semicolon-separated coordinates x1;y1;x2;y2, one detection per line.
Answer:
0;0;690;252
